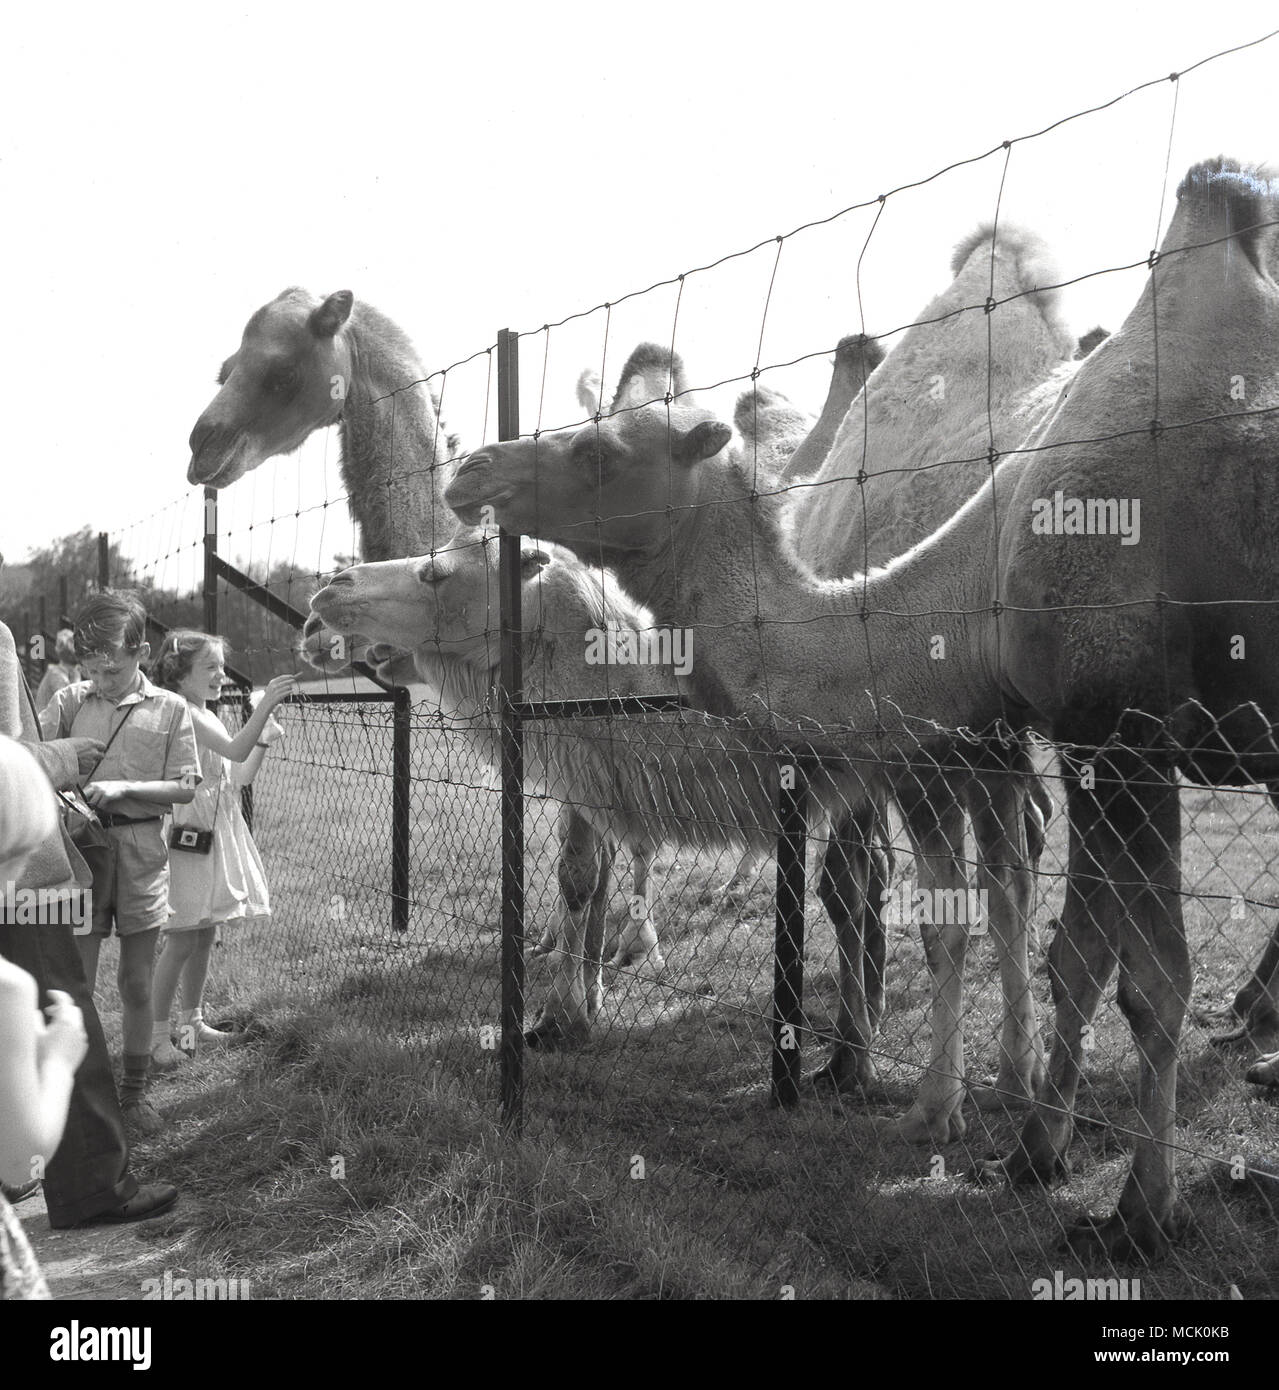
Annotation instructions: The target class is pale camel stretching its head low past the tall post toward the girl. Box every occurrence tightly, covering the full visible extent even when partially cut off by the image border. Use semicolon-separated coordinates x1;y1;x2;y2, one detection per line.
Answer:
303;531;861;1045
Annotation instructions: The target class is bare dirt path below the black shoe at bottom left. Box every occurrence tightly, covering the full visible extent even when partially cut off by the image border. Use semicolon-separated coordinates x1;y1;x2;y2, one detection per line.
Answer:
17;1190;192;1301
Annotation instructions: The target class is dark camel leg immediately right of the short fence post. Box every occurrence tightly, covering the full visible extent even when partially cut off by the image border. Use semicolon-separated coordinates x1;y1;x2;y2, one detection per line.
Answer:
813;799;887;1091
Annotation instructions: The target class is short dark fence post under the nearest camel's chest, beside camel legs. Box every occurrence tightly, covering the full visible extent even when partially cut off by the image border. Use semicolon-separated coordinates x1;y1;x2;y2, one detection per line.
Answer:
772;763;808;1108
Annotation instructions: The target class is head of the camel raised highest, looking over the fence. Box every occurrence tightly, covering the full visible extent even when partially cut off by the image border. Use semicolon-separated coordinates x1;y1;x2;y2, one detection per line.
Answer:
186;288;355;488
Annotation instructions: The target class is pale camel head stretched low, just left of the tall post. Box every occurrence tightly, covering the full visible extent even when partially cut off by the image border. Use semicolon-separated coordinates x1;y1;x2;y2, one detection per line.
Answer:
311;531;551;660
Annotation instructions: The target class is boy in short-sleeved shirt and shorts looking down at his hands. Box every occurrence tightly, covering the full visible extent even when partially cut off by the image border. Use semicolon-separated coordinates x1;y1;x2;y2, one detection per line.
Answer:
40;589;200;1134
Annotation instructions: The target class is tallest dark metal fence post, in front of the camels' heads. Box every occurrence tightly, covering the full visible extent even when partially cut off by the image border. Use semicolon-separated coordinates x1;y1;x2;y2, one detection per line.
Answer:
498;328;524;1134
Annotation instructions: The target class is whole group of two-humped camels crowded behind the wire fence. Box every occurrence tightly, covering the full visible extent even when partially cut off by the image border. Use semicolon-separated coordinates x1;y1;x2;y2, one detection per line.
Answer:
188;158;1279;1259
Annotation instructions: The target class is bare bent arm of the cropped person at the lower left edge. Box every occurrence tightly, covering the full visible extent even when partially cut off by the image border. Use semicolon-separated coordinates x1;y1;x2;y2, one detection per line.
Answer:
0;959;89;1187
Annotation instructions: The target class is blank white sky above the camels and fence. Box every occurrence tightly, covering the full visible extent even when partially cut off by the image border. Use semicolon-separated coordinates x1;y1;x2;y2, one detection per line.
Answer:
0;0;1279;587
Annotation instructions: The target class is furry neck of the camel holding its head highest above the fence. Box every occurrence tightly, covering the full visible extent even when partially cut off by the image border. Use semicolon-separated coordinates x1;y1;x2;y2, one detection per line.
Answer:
342;318;456;560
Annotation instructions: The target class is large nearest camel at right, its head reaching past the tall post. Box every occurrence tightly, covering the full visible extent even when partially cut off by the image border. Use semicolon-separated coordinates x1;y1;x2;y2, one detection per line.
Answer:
445;160;1279;1259
